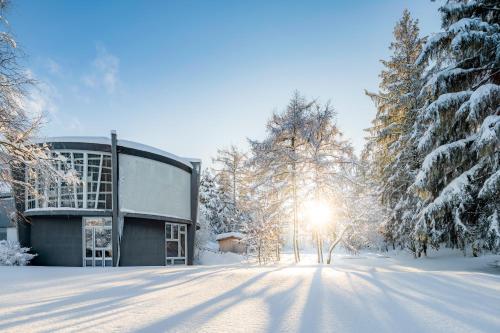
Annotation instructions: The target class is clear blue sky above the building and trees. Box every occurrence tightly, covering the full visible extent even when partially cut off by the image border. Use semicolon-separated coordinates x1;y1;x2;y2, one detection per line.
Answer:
8;0;440;162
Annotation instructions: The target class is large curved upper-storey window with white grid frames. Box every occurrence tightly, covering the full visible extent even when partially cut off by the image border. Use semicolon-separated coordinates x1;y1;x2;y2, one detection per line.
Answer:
26;151;112;209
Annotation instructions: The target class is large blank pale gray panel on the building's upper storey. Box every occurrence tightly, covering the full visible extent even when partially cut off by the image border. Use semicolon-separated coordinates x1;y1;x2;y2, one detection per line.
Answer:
118;154;191;220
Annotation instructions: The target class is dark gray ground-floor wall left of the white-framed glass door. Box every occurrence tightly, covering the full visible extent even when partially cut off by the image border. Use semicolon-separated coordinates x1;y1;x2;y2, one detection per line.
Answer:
31;216;83;266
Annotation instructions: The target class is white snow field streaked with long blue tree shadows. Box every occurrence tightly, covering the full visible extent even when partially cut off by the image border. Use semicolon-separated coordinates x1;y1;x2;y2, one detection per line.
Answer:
0;253;500;333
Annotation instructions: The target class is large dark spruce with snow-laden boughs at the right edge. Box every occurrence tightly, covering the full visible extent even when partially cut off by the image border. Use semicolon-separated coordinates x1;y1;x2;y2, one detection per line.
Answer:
412;0;500;255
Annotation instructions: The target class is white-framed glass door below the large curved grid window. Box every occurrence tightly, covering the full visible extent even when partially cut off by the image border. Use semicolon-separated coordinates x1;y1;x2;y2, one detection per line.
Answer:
83;217;113;267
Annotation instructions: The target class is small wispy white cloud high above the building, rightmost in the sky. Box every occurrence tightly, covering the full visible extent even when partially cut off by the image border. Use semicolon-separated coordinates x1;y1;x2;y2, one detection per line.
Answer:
82;45;120;94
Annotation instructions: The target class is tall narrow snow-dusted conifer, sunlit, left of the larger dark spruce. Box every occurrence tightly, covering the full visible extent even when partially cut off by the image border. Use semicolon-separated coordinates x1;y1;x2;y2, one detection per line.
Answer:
367;10;424;249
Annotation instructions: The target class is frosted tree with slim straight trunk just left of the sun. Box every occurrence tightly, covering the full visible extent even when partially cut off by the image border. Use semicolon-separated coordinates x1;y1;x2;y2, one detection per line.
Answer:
249;92;313;262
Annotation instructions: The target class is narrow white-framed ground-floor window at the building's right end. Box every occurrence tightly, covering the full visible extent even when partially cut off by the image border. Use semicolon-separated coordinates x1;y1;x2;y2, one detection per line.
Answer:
165;223;187;265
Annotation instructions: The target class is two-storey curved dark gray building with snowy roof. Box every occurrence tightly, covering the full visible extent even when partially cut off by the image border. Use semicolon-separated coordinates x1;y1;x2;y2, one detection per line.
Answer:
16;132;200;267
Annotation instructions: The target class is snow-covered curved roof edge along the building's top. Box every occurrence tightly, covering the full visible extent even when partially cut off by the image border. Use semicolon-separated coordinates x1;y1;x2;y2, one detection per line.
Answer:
34;136;195;169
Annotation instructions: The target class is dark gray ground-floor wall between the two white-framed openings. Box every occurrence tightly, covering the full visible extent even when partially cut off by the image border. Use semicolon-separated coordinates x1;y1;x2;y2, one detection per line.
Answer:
120;217;165;266
